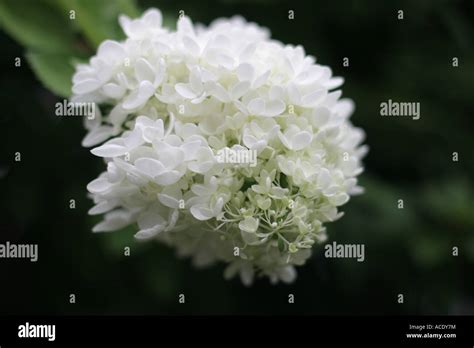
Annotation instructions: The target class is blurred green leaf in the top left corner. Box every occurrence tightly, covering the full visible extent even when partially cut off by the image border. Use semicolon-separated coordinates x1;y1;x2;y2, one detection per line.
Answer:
0;0;75;52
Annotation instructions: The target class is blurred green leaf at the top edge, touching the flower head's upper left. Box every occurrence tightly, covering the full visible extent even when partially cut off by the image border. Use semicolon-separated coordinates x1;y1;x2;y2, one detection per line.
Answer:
57;0;140;47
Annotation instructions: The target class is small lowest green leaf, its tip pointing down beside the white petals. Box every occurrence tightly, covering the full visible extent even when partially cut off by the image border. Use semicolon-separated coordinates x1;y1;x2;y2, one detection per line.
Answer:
26;52;74;98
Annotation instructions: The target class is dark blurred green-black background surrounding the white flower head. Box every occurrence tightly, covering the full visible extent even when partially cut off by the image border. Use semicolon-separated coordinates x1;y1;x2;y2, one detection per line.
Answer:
0;0;474;314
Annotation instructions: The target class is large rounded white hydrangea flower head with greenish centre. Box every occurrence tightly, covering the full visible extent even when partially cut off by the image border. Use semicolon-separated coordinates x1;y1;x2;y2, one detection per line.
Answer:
72;9;366;284
